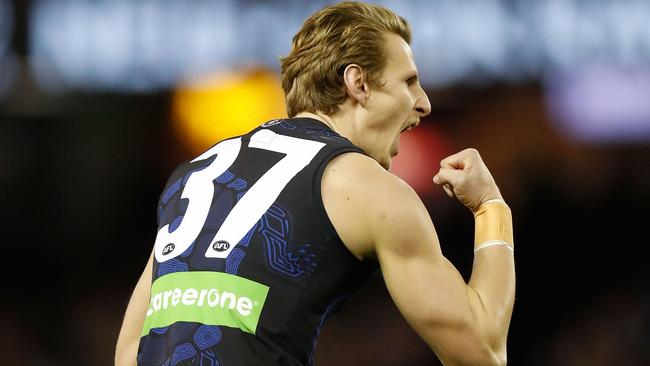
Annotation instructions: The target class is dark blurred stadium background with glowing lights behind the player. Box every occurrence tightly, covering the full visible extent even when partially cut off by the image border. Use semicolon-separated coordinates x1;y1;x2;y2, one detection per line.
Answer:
0;0;650;366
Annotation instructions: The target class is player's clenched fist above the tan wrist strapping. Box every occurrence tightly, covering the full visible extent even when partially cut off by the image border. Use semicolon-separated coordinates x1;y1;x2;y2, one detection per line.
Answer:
433;149;503;212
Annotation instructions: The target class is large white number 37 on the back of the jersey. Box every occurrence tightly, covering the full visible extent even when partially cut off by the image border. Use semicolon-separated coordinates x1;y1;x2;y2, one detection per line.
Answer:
155;130;325;262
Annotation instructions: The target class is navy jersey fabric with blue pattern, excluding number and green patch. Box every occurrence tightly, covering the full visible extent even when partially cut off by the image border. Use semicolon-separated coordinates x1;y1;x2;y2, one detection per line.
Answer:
138;119;376;366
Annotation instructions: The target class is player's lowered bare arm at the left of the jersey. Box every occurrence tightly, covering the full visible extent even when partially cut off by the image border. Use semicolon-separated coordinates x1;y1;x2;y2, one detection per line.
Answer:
115;252;153;366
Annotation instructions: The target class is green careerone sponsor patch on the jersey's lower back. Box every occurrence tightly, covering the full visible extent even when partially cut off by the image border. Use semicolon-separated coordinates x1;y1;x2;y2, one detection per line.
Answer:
141;272;269;336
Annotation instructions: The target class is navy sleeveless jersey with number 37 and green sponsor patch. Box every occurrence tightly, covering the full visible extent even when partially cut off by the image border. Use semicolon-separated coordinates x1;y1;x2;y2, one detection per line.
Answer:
138;118;377;366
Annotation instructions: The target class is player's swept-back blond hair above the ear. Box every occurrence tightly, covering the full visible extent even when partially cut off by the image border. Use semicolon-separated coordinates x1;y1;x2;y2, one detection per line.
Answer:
281;2;411;117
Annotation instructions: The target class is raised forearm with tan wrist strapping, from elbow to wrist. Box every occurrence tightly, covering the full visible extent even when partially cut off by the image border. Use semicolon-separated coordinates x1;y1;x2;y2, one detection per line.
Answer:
469;201;515;356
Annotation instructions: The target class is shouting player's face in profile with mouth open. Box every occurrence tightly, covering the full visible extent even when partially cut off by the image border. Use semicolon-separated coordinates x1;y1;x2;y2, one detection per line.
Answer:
362;33;431;169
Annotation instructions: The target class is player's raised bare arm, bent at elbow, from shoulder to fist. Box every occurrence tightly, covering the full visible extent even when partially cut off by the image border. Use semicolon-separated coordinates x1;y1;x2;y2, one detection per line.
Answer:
322;150;515;365
